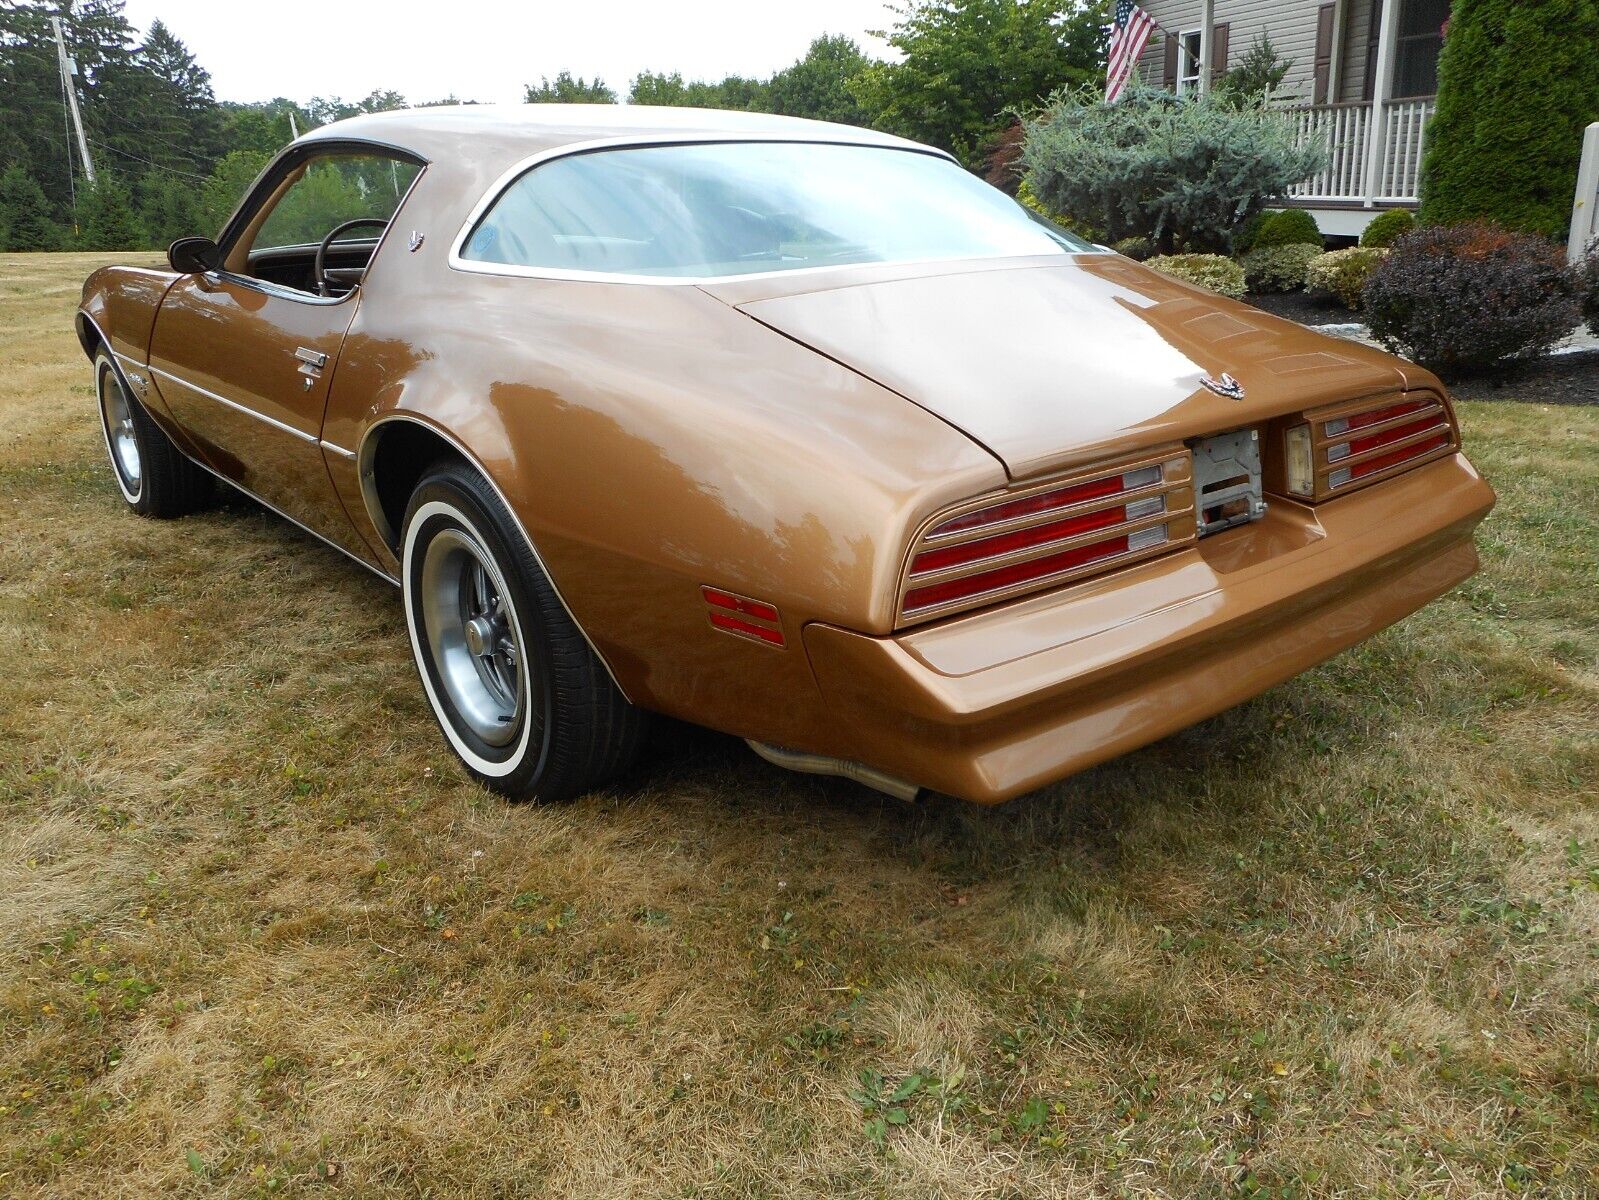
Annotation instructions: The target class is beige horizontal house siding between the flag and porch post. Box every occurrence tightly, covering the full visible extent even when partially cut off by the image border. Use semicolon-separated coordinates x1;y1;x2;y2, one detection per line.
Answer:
1138;0;1355;104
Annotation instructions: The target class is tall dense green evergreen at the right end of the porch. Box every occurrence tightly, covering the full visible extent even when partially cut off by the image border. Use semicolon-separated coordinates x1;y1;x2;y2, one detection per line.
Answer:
1422;0;1599;238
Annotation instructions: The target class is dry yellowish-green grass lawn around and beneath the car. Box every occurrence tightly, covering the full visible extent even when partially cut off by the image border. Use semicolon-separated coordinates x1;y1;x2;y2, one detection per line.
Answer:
0;254;1599;1198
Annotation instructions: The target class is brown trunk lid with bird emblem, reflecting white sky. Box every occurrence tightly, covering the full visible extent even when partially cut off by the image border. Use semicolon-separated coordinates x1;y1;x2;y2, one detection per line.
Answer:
723;254;1406;477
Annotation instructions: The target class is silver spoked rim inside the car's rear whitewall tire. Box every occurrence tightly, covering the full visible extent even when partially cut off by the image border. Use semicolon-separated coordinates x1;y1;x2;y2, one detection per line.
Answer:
417;528;528;746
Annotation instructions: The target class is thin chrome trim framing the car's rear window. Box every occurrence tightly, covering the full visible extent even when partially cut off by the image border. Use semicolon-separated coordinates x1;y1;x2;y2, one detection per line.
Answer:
444;133;1094;288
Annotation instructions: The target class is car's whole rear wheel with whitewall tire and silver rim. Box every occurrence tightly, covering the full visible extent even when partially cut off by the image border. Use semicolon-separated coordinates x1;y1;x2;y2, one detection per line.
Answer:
401;462;644;800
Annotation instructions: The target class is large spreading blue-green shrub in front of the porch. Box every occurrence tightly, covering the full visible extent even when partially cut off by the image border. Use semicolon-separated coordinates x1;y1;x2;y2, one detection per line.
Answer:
1022;85;1327;251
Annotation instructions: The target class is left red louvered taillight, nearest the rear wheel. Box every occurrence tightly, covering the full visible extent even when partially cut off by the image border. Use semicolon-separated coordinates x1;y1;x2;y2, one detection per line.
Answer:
900;451;1194;621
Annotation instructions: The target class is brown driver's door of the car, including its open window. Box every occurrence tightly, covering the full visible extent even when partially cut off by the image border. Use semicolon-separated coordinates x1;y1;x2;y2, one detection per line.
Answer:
150;144;419;562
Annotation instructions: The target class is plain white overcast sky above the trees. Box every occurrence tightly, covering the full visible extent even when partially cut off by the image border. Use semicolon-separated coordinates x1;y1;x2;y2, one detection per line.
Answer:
116;0;892;102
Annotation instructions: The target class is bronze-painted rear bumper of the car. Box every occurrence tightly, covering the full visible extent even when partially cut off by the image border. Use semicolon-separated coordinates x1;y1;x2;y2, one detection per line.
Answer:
804;454;1493;803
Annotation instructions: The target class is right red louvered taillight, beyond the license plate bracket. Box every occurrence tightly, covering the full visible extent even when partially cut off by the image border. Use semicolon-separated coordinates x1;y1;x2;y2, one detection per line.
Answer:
1284;394;1457;499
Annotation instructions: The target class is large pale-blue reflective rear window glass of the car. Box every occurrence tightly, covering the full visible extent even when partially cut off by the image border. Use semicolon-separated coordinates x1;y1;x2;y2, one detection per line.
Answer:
461;142;1094;278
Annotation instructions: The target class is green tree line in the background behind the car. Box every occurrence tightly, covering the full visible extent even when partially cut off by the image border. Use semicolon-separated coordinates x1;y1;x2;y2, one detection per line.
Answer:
0;0;1107;250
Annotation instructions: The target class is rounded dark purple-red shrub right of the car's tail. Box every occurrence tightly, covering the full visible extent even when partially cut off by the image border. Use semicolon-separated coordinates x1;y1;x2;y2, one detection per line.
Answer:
1361;224;1581;374
